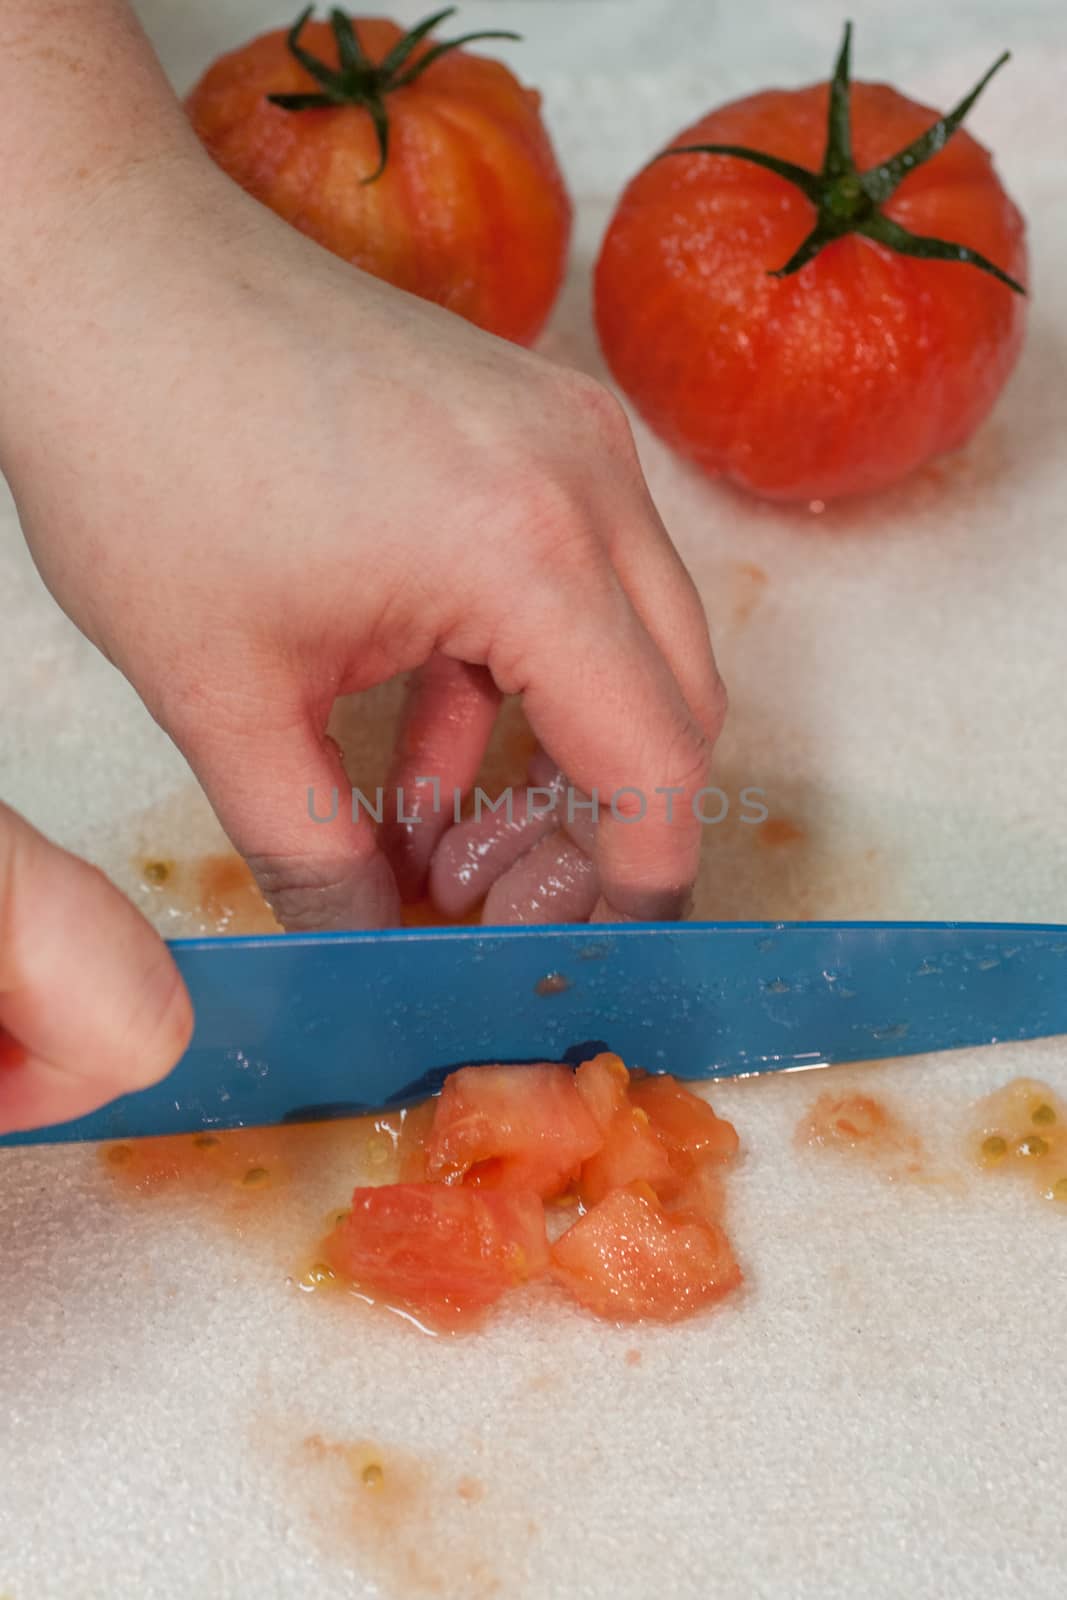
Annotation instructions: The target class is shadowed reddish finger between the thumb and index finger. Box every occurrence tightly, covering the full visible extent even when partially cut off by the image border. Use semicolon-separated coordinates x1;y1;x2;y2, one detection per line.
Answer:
379;654;501;904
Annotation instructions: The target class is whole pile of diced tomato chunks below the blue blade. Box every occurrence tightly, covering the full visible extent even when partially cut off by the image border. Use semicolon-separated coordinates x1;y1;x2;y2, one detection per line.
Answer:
326;1054;741;1330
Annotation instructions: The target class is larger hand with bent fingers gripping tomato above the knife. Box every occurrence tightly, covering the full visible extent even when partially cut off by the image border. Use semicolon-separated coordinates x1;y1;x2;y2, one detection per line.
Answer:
0;156;725;928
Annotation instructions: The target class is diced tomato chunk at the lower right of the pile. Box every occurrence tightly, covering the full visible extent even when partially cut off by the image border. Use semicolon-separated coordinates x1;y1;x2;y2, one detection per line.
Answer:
552;1184;741;1322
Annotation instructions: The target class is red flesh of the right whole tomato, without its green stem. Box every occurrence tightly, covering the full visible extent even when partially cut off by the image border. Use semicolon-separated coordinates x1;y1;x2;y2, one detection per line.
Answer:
595;83;1027;501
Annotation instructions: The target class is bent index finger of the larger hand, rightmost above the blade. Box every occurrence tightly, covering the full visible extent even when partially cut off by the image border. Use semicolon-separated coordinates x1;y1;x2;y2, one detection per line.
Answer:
494;573;709;918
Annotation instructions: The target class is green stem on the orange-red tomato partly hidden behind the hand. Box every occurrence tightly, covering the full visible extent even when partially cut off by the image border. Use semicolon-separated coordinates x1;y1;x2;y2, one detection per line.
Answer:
267;5;522;184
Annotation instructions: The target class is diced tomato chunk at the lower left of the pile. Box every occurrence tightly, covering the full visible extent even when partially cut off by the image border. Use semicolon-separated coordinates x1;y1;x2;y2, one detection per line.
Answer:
326;1184;549;1330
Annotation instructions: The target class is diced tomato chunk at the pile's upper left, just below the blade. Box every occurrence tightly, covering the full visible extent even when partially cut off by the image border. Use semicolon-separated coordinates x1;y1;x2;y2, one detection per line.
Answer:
426;1066;603;1200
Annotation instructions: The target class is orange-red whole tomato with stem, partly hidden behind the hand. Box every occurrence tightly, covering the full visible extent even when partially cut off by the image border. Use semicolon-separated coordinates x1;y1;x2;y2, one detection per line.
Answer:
186;8;571;344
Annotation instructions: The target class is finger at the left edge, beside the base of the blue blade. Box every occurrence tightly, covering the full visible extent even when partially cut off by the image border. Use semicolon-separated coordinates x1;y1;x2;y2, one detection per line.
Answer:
0;806;192;1133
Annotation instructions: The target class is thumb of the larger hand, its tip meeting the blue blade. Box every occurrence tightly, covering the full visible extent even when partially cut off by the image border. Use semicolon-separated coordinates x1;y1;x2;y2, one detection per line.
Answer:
174;693;400;931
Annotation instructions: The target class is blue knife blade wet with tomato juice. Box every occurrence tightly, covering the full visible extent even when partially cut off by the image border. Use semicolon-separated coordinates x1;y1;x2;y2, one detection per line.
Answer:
0;922;1067;1146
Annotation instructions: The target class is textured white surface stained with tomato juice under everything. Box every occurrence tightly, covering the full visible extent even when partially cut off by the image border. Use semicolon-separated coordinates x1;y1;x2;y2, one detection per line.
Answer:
0;0;1067;1600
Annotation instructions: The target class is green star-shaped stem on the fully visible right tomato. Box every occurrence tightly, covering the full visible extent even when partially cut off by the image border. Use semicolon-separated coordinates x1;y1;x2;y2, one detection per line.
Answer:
654;22;1025;294
